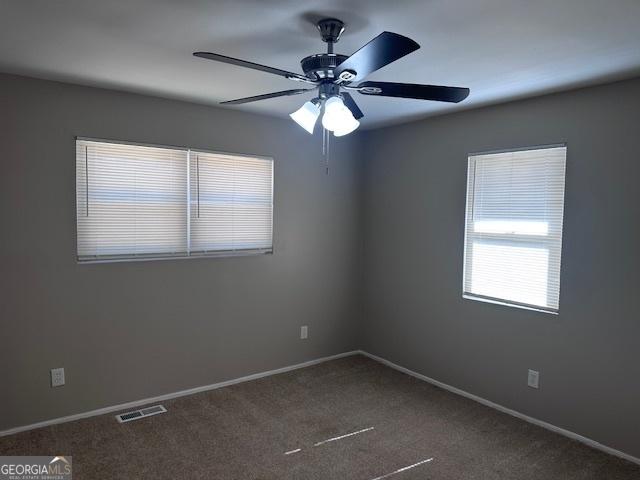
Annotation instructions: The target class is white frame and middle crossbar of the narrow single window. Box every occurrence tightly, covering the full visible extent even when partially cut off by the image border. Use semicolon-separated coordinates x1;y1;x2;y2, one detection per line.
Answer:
462;142;569;315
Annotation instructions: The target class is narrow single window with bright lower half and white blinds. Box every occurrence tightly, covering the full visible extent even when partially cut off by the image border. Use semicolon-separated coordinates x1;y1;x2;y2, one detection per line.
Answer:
463;146;566;313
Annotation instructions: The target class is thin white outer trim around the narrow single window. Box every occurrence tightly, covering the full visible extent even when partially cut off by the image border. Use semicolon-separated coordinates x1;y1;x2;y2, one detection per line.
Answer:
462;142;569;315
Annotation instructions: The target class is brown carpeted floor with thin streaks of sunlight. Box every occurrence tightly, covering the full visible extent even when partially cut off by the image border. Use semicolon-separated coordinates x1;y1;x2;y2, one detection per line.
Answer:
0;356;640;480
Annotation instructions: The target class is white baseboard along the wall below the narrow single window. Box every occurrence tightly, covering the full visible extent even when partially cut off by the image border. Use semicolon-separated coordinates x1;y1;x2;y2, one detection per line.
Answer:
358;350;640;465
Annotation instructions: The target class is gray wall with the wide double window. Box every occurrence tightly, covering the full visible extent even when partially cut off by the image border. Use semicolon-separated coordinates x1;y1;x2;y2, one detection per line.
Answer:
0;75;361;430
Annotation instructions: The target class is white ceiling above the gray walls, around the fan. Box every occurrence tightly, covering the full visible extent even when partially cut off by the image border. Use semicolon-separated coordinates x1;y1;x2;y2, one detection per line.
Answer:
0;0;640;127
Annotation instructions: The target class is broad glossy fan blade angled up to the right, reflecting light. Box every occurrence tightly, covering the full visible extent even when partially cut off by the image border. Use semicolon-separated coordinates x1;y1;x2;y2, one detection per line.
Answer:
333;32;420;82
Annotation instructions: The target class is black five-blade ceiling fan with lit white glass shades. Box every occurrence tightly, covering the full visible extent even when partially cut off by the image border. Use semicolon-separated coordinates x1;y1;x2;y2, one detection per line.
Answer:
194;18;469;137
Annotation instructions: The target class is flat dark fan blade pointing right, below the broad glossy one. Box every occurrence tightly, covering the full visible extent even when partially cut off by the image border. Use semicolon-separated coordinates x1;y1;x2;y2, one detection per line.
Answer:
354;82;470;103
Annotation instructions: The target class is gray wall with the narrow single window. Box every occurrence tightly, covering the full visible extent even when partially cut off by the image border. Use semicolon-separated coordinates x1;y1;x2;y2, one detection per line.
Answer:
363;80;640;457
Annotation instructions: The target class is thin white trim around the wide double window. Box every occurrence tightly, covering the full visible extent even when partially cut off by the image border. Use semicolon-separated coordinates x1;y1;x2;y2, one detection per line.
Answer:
74;136;276;265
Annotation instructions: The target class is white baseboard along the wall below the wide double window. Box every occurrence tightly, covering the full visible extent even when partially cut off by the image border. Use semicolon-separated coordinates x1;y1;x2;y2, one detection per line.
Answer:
0;350;360;437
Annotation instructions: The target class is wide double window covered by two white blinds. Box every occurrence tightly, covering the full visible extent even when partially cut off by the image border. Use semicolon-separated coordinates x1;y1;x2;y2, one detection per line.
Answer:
76;139;273;261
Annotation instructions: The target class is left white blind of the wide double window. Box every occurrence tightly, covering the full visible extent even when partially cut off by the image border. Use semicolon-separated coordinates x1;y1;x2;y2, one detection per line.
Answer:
76;140;187;260
